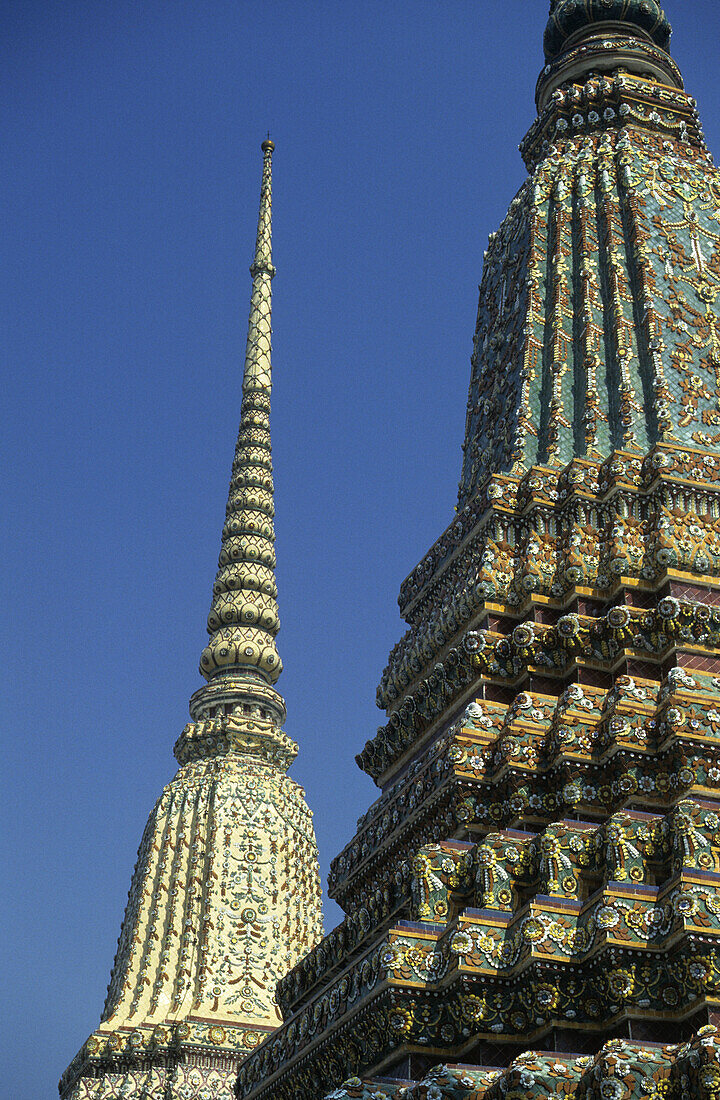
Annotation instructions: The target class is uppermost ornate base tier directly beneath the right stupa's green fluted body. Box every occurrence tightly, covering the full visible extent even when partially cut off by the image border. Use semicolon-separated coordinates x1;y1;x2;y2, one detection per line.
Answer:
371;443;720;785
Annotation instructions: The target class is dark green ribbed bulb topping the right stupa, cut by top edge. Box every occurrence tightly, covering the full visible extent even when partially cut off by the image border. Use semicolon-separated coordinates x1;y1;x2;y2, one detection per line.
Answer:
544;0;672;61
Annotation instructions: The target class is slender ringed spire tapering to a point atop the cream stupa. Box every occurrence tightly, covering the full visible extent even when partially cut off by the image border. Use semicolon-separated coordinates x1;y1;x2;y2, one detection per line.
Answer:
198;139;283;703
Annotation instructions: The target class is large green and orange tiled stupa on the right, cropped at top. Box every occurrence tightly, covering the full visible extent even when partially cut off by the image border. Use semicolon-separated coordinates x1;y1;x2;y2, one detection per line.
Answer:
236;0;720;1100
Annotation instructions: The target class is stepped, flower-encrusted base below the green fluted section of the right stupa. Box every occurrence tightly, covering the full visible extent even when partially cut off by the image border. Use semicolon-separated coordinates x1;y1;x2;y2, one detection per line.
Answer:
237;446;720;1100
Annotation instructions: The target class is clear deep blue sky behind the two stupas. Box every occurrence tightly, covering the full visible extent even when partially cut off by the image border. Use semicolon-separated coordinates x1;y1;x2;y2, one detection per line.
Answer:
5;0;720;1100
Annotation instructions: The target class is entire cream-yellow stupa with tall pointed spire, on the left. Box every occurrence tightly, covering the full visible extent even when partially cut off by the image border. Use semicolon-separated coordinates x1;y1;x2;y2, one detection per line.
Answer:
59;141;322;1100
